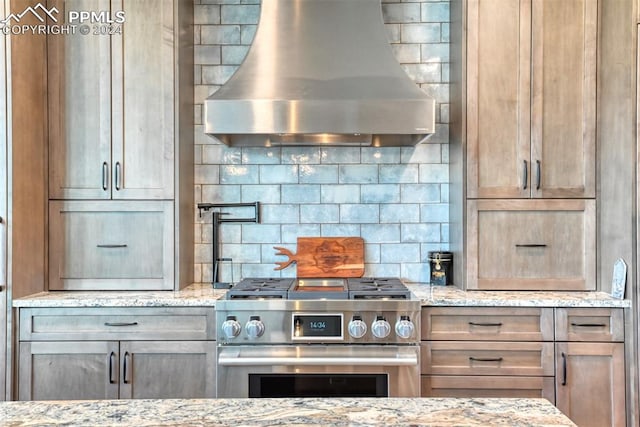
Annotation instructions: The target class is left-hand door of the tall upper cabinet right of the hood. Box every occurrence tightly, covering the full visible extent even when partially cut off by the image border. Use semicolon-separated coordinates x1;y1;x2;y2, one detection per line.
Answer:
467;0;531;198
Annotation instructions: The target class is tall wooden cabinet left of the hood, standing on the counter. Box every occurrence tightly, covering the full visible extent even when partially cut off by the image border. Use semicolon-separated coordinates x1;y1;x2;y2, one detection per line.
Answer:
47;0;193;290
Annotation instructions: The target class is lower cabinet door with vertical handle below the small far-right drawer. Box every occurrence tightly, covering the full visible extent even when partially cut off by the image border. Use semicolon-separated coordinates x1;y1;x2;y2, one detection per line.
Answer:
556;342;626;427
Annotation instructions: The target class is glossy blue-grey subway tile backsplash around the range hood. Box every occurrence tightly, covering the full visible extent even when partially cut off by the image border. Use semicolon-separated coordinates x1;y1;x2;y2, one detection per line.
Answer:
194;0;450;282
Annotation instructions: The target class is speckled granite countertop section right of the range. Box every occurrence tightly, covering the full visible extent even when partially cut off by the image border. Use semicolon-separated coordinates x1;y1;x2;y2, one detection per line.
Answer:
407;283;631;308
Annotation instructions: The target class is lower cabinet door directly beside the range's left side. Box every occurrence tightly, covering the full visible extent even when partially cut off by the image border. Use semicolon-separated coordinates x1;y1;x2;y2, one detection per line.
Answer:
120;341;216;399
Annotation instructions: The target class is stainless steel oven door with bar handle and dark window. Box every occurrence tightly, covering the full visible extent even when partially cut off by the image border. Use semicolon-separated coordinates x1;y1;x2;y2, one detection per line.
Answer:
217;345;420;398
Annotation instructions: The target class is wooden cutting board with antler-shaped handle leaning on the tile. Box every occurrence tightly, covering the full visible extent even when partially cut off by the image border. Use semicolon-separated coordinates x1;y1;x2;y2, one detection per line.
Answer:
273;237;364;278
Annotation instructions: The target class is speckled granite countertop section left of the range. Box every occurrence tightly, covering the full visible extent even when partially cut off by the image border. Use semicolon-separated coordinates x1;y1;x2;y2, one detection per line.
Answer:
13;283;226;307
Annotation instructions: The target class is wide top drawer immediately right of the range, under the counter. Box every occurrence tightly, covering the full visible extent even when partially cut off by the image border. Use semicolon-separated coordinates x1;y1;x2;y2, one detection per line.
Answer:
421;307;553;341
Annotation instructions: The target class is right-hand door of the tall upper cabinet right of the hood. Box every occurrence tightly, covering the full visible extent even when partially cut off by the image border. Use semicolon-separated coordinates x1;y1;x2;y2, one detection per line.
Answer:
531;0;598;198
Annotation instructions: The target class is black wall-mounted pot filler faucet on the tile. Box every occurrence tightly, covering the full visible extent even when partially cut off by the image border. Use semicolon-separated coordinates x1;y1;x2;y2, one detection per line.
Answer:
198;202;260;289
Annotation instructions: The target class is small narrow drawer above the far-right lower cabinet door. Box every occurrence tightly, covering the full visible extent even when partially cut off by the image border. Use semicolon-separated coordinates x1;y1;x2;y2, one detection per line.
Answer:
556;308;624;342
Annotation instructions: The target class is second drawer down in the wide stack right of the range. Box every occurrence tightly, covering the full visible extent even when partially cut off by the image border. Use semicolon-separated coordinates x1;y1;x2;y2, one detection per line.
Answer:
421;341;554;376
